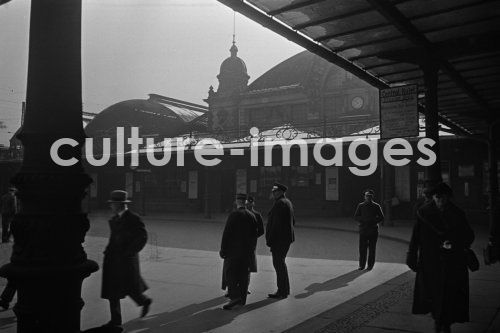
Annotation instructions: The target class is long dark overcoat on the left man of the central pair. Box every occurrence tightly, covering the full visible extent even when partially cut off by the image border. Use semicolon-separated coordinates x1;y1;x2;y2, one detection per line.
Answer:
219;207;256;289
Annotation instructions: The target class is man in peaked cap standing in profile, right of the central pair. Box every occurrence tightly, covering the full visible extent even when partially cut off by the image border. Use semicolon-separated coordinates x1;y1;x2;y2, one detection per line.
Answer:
266;183;295;299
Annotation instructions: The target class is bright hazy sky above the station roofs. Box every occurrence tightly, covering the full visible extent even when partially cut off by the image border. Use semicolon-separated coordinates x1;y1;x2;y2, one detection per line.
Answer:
0;0;302;145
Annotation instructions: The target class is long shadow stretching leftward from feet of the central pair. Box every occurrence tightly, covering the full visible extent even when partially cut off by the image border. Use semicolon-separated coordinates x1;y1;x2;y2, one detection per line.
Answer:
123;297;276;333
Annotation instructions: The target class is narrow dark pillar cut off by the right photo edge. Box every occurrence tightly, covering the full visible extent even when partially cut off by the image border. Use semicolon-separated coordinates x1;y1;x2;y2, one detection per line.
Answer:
488;123;500;260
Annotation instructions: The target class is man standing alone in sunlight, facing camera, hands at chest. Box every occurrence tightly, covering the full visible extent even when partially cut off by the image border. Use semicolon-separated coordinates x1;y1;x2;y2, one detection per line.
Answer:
354;190;384;271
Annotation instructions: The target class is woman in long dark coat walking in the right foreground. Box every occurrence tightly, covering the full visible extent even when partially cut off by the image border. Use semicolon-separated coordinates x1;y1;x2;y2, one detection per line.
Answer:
407;183;474;332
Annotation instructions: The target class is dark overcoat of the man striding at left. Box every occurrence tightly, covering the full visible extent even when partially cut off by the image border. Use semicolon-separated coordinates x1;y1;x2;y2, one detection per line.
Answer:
101;210;148;299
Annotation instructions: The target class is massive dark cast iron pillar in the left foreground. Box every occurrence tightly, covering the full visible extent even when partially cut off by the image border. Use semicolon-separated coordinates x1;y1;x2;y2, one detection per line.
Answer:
0;0;98;333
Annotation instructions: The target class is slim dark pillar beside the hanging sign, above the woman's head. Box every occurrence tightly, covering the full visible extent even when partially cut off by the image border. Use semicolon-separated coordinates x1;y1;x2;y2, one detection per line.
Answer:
421;60;442;185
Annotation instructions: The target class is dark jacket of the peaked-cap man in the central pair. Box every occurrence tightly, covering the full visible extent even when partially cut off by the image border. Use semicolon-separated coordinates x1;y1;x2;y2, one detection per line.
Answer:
266;196;295;248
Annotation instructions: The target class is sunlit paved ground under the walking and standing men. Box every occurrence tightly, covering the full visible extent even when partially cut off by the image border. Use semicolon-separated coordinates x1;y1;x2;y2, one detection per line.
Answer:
0;237;408;333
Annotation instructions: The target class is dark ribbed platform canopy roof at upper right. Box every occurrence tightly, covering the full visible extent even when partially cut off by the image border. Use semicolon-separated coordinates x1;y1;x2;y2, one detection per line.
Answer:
218;0;500;135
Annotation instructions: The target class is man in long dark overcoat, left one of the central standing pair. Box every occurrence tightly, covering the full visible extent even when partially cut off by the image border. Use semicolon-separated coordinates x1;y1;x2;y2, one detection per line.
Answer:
219;194;256;310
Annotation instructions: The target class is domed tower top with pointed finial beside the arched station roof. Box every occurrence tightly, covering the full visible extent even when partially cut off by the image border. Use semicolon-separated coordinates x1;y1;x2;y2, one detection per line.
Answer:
217;40;250;96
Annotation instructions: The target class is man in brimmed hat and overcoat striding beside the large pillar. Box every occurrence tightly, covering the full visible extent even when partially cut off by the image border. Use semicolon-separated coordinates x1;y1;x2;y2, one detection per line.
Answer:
101;190;152;332
